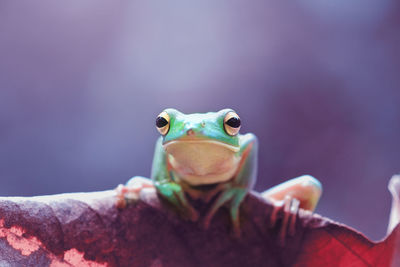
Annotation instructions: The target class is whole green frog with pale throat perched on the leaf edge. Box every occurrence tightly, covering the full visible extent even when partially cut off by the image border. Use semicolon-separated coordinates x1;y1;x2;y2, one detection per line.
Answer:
116;108;322;235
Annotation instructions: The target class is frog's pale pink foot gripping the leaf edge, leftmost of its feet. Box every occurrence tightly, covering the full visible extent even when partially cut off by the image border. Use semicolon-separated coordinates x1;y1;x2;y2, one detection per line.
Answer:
115;176;154;209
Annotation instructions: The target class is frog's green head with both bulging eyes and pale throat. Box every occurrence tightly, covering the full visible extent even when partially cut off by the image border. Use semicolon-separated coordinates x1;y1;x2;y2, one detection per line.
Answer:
156;109;240;185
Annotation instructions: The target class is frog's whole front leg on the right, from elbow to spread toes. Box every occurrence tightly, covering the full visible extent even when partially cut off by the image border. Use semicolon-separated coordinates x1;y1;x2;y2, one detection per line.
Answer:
204;134;258;236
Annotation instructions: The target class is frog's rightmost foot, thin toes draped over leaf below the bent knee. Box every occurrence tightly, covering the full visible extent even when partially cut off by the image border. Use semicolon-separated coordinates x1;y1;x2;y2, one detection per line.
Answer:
269;196;300;246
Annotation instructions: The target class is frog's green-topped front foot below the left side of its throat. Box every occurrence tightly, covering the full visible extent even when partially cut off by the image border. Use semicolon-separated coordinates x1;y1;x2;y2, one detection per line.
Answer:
156;182;199;221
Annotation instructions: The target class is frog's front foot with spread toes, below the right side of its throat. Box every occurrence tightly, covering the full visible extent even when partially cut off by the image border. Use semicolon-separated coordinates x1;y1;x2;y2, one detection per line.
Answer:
203;187;247;237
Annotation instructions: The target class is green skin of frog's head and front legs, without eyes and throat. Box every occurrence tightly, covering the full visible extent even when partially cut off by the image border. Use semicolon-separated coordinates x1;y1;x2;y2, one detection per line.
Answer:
151;109;258;232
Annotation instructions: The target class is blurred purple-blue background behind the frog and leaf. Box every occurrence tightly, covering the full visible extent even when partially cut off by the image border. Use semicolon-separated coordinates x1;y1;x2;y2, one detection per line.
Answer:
0;0;400;243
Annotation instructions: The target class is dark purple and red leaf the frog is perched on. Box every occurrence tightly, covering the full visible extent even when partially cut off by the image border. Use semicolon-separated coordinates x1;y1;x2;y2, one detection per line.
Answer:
0;191;400;266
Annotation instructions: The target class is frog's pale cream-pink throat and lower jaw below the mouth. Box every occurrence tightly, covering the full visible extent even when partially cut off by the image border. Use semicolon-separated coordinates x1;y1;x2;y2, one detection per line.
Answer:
164;139;240;186
